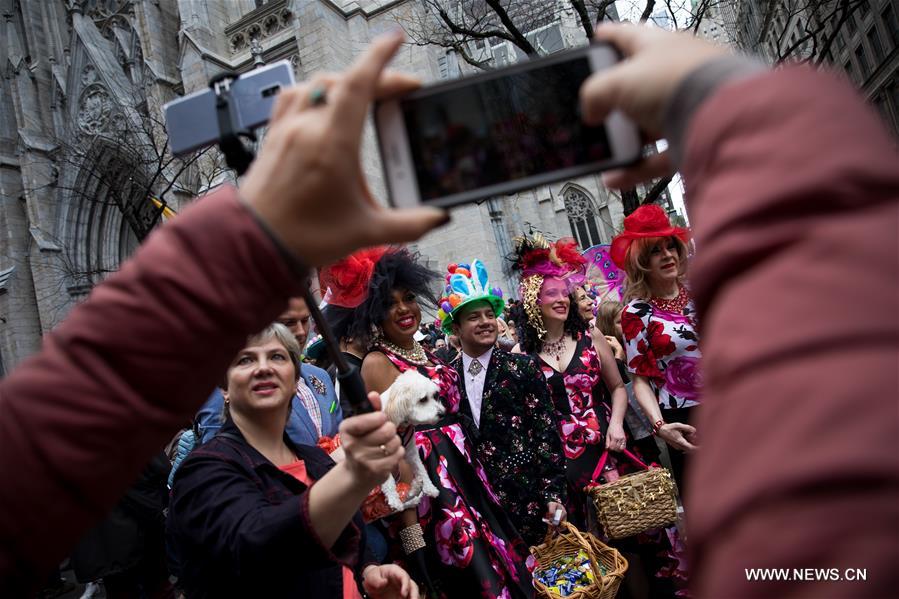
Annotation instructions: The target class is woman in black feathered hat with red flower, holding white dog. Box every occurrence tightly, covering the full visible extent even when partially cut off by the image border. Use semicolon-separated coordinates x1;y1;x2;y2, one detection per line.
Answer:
321;248;534;599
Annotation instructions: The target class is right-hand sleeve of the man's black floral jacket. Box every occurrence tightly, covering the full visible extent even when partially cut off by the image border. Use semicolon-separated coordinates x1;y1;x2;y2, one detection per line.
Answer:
524;358;568;503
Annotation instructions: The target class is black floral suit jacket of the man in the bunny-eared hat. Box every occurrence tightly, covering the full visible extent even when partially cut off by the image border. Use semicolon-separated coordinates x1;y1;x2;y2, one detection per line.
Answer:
452;349;566;543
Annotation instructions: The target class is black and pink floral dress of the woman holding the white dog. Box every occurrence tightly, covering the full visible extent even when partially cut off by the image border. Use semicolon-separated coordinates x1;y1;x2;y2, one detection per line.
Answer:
379;347;534;599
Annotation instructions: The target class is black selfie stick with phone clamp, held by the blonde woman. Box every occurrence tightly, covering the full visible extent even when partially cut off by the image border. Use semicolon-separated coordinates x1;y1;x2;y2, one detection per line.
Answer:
209;71;374;414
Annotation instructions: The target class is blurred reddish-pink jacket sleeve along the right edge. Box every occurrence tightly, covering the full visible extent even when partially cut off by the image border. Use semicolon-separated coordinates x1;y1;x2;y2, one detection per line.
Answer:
684;67;899;597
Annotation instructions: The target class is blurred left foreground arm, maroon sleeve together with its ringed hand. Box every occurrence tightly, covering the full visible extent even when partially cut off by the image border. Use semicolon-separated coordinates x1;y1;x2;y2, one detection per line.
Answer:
0;30;446;596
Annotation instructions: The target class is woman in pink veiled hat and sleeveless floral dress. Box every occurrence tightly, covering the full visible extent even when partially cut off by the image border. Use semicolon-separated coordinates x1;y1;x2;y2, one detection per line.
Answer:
515;235;627;529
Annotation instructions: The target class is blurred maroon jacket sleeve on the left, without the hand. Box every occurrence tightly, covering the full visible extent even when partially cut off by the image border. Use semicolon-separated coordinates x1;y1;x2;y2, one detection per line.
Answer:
0;188;300;596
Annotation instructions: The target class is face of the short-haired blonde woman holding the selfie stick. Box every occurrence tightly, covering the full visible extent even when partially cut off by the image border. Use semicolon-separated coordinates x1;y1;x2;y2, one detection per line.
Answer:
225;338;297;418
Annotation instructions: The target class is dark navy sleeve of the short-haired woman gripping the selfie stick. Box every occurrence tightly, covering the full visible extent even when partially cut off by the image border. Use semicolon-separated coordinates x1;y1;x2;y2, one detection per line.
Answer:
169;449;361;576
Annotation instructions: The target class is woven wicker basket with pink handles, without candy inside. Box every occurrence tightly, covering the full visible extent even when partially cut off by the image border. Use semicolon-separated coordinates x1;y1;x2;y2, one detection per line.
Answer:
585;452;677;539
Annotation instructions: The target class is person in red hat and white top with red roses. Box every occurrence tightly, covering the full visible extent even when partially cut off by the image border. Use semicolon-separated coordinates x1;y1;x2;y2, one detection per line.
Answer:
610;204;702;488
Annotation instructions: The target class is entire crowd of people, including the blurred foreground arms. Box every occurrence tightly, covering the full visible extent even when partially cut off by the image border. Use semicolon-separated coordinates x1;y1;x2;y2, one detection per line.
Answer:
0;21;899;599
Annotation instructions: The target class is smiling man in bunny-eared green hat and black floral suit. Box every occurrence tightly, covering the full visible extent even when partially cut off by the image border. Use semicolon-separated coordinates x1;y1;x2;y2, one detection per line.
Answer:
438;260;566;545
